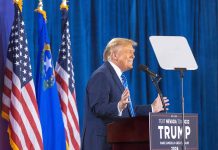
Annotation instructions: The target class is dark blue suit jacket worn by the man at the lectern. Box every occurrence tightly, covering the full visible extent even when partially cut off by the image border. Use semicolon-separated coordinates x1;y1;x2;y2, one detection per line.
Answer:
82;62;151;150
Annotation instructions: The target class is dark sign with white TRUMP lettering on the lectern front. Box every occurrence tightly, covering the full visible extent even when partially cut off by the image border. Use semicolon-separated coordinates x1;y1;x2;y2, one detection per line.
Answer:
149;113;198;150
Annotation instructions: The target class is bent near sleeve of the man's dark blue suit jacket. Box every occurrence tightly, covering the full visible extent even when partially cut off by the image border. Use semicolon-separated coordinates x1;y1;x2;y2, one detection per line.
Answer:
87;72;119;117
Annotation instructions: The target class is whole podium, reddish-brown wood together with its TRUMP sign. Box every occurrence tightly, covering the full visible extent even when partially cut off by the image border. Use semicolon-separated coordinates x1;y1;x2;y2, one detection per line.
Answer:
107;113;198;150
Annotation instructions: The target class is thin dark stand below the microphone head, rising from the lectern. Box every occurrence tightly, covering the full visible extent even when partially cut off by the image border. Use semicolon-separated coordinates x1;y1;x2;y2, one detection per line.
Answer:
150;75;167;113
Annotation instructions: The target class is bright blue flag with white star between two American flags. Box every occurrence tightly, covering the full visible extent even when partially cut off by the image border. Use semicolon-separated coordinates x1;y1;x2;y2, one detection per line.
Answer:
36;10;66;150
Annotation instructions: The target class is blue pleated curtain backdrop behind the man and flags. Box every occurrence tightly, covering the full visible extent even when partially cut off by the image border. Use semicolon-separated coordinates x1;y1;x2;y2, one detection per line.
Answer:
0;0;218;150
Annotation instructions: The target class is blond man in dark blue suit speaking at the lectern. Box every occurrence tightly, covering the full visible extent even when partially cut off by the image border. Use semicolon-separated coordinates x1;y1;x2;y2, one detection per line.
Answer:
82;38;169;150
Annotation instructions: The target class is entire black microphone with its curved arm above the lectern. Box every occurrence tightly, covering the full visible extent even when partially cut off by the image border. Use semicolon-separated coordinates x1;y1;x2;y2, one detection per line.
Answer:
139;64;167;112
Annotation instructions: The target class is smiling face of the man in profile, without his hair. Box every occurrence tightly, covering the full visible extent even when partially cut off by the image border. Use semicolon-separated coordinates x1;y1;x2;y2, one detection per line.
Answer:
114;44;135;72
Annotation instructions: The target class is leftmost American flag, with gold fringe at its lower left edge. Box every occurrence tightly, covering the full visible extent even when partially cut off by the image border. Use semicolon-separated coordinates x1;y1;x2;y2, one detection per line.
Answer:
2;3;43;150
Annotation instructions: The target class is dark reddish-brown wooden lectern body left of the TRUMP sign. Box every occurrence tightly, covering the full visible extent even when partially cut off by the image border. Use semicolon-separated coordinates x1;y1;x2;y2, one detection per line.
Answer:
107;116;149;150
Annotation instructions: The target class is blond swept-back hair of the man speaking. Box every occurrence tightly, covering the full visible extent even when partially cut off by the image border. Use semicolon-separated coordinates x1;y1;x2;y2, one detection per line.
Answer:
103;38;137;62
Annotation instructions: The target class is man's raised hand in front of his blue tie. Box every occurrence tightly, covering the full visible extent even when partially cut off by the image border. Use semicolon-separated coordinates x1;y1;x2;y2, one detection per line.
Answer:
118;89;130;111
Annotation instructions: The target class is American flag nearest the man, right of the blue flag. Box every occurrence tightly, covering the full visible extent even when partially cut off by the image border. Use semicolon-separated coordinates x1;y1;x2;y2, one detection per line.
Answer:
55;6;80;150
